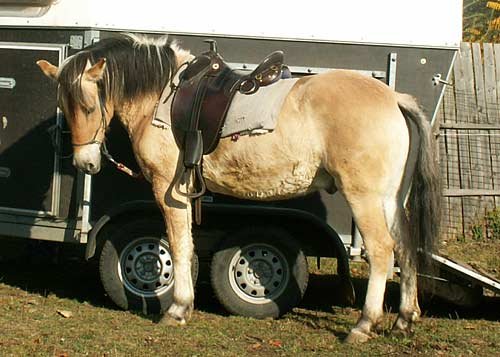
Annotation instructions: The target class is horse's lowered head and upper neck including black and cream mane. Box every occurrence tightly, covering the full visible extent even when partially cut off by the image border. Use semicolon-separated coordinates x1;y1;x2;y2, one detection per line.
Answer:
37;34;190;174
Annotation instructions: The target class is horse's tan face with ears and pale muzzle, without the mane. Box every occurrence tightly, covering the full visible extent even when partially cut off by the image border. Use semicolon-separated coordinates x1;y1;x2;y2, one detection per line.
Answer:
37;58;113;174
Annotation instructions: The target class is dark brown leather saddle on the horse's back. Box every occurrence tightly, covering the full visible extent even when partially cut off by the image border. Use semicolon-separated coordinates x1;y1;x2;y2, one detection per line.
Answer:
171;40;283;169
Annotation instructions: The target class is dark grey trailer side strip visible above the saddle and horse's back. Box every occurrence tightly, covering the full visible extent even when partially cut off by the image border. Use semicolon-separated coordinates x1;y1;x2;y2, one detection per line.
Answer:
162;35;455;116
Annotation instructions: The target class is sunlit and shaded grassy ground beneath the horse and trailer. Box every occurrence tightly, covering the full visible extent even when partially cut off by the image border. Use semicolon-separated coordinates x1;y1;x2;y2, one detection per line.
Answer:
0;241;500;356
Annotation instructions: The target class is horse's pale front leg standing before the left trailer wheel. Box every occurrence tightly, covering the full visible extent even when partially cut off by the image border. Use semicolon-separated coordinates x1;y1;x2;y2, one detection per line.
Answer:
154;177;194;325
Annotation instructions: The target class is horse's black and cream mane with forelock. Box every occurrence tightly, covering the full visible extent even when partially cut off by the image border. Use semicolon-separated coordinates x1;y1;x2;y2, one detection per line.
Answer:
58;34;177;112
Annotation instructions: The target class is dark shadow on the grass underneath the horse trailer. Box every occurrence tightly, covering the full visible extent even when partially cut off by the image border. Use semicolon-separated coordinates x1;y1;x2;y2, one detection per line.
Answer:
0;239;500;324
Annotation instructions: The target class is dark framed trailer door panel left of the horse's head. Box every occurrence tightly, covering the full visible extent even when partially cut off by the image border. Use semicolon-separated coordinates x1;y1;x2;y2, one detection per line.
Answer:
0;44;59;212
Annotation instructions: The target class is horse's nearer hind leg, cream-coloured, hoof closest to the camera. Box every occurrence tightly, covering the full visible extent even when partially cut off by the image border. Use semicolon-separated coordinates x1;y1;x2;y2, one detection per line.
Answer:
346;195;394;343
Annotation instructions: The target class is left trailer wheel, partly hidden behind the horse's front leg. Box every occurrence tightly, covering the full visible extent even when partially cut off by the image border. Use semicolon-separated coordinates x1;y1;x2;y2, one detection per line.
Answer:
99;219;198;314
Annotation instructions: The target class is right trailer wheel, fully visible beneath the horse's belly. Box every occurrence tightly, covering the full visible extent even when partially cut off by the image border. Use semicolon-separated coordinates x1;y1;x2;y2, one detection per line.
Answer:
211;227;309;318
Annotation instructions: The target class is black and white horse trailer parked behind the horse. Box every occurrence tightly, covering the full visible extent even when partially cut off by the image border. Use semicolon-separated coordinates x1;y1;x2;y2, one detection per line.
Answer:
0;0;498;317
